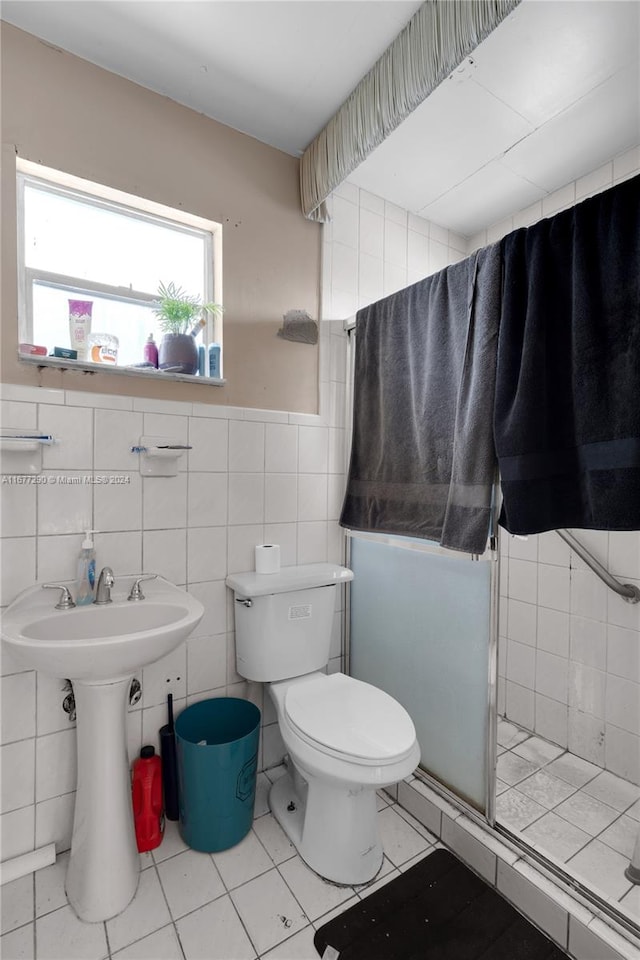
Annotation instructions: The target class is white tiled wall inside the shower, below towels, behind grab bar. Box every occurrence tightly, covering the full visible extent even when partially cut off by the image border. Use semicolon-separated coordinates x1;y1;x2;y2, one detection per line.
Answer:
499;530;640;783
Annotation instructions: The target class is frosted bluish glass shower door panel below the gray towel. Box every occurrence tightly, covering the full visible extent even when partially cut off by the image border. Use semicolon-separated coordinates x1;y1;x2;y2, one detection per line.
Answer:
349;532;497;822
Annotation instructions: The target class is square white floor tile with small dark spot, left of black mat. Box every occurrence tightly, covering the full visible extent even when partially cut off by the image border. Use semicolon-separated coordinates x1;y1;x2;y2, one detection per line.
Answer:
231;869;309;960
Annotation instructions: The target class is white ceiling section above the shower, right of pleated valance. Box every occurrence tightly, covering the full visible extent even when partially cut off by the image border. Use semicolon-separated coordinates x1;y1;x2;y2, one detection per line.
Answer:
349;0;640;236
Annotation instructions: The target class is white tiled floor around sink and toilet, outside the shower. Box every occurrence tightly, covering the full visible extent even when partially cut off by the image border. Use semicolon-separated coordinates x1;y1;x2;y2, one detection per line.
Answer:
0;768;441;960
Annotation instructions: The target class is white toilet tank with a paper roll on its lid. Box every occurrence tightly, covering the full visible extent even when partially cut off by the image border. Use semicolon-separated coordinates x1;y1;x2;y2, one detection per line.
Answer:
226;563;353;682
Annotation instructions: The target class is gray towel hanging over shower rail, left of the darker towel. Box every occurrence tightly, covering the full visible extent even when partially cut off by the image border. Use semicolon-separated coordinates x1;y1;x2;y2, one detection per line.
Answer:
340;245;501;553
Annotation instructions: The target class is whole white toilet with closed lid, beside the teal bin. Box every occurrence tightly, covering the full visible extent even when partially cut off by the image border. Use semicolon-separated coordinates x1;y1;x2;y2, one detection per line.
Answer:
227;563;420;885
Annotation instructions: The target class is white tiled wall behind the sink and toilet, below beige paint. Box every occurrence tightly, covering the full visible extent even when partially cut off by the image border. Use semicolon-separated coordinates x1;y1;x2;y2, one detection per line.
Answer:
1;376;346;857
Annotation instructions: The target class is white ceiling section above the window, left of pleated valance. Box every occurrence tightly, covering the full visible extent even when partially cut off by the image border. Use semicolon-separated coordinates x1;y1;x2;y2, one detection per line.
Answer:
0;0;420;156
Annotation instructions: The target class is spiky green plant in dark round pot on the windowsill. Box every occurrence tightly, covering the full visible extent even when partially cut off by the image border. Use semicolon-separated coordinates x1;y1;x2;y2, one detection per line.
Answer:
153;282;222;374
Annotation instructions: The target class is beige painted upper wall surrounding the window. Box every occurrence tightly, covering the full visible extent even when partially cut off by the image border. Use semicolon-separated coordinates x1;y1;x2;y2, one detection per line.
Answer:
1;24;321;413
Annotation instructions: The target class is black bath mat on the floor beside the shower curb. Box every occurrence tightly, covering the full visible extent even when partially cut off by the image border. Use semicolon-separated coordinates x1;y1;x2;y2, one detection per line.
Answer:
313;850;567;960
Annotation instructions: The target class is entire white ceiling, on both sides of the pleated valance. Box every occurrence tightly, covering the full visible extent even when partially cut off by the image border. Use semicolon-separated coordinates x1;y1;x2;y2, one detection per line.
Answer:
0;0;640;236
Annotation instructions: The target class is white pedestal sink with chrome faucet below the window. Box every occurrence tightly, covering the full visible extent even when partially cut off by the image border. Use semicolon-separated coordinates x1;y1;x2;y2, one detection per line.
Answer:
2;577;204;922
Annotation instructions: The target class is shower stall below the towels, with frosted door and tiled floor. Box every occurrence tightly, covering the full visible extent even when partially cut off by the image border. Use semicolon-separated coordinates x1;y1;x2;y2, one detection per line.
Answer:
348;530;640;930
